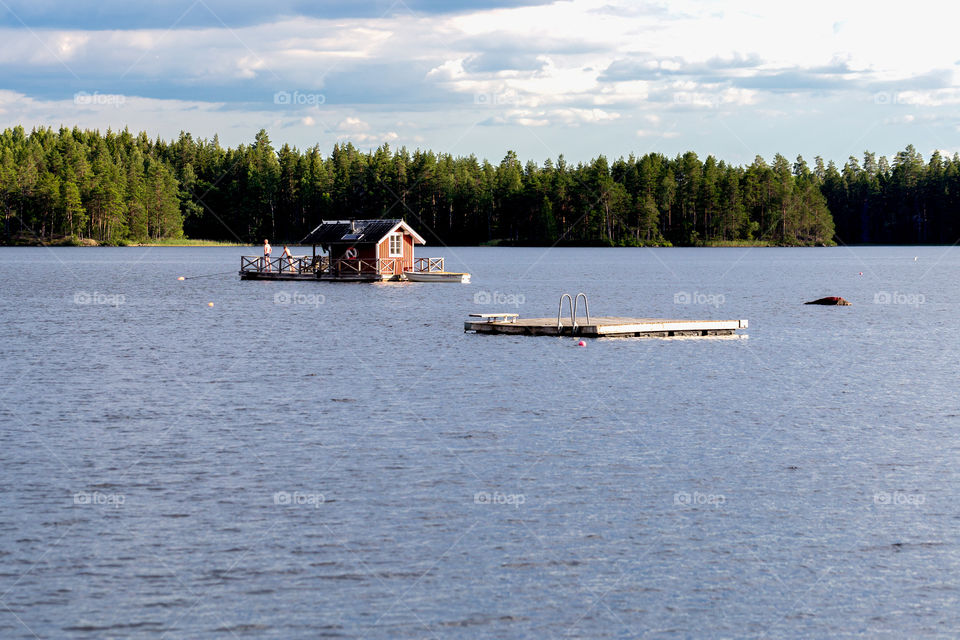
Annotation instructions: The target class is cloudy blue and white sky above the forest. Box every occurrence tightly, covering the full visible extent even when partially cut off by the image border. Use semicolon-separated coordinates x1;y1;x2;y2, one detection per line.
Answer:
0;0;960;164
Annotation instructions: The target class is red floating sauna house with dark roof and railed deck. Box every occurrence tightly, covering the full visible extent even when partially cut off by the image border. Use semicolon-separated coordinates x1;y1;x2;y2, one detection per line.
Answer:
240;219;469;282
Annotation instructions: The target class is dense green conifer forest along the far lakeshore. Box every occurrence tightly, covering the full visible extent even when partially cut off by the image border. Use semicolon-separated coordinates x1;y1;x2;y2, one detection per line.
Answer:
0;127;960;246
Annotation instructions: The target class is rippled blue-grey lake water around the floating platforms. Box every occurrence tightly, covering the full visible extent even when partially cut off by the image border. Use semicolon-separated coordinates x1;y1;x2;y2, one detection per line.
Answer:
0;247;960;639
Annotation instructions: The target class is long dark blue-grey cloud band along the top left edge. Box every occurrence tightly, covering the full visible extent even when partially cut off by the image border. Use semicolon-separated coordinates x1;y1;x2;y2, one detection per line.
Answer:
0;0;550;30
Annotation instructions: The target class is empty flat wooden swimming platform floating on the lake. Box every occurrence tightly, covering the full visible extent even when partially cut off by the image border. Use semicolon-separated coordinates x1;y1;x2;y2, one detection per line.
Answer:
463;316;748;338
